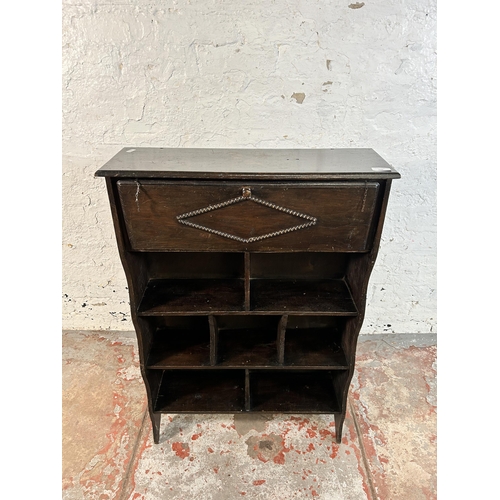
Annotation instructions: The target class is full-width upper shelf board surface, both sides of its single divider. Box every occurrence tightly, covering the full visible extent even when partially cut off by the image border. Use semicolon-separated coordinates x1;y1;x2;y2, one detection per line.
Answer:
138;279;358;316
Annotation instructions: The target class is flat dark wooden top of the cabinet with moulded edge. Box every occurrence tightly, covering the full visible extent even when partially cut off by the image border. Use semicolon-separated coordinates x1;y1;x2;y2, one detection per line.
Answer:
95;147;400;180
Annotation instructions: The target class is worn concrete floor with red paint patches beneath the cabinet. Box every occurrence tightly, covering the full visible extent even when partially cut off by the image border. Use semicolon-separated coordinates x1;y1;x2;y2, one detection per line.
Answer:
62;331;437;500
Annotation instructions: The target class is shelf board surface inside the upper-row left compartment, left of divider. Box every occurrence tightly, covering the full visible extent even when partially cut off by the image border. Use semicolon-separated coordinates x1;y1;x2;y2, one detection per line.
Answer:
138;279;245;316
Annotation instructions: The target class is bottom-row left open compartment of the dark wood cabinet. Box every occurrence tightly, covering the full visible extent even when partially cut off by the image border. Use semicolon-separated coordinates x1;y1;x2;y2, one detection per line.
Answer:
154;370;245;413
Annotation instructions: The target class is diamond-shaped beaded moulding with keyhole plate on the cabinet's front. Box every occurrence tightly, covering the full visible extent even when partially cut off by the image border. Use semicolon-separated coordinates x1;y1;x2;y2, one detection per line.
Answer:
177;187;318;243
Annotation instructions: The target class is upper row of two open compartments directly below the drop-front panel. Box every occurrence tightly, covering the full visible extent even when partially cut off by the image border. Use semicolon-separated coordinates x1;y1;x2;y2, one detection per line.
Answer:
138;252;358;316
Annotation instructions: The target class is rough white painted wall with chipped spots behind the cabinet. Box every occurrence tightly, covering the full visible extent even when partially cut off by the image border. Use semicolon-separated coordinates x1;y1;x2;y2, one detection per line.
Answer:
63;0;436;333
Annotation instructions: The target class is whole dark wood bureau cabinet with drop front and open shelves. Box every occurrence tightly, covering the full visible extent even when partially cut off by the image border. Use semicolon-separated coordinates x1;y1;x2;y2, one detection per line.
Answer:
96;148;400;443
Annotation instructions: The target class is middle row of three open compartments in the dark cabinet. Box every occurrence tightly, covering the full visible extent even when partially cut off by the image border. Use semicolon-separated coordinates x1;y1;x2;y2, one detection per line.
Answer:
146;315;349;370
